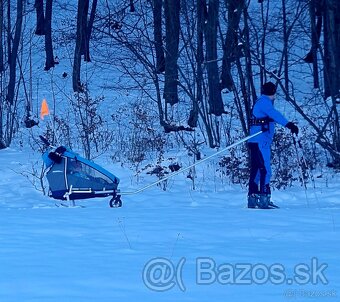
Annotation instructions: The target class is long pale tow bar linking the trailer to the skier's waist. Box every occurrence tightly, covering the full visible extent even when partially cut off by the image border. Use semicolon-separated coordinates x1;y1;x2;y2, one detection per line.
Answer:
119;131;263;195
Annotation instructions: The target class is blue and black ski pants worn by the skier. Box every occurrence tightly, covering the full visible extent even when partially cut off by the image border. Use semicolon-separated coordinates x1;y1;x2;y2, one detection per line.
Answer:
248;143;271;195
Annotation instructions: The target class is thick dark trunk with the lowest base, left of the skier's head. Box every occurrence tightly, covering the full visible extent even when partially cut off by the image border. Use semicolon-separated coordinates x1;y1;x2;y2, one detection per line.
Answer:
205;0;224;116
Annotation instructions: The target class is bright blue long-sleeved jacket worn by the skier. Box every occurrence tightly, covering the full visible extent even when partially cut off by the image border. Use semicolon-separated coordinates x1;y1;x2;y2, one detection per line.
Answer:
249;95;288;145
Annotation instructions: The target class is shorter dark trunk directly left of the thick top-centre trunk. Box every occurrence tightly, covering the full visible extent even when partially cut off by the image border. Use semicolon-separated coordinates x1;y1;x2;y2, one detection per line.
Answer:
153;0;165;73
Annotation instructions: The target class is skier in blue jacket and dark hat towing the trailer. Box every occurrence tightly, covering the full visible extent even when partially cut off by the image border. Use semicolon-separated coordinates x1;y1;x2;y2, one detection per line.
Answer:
248;82;299;209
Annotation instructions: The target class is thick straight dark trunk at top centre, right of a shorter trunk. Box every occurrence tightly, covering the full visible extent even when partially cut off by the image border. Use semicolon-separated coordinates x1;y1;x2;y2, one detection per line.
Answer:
163;0;180;105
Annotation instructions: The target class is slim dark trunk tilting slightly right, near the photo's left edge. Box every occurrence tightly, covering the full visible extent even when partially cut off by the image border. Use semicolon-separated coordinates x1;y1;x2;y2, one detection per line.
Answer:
7;0;23;105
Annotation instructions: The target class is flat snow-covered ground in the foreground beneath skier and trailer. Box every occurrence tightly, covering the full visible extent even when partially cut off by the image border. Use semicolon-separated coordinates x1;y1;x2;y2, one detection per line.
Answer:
0;145;340;302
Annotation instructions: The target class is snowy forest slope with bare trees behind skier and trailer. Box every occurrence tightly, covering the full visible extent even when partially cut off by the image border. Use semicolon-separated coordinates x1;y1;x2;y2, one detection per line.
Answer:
0;0;340;188
